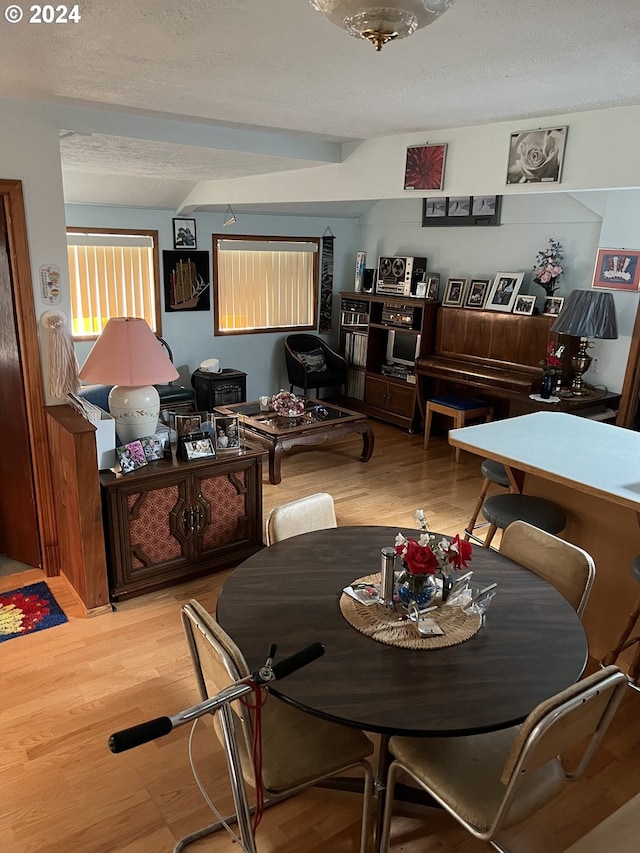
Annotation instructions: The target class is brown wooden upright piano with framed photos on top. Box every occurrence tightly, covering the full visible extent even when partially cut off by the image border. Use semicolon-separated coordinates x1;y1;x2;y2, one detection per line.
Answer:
415;307;576;416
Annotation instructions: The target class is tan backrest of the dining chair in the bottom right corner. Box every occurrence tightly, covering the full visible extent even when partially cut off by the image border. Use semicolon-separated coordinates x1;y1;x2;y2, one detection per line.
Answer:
501;666;628;790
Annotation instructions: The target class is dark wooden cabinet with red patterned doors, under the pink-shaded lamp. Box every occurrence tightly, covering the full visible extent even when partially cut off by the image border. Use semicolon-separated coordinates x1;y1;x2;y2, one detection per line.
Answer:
100;450;264;601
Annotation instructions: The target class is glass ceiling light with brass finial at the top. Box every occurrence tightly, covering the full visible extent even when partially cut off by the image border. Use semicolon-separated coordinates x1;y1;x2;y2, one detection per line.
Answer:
310;0;455;50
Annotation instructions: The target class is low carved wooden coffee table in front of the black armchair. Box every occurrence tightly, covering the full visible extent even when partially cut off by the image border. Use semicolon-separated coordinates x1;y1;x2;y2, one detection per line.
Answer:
216;397;374;486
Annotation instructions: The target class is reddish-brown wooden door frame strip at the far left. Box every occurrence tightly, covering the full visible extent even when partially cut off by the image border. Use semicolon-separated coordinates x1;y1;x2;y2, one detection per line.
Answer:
0;178;60;576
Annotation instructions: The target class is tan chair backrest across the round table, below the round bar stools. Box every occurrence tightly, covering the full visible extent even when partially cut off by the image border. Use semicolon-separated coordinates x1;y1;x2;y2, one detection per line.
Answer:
500;521;596;616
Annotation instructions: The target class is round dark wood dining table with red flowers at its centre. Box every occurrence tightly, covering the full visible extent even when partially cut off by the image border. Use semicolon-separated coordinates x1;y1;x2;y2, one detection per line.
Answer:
216;526;588;736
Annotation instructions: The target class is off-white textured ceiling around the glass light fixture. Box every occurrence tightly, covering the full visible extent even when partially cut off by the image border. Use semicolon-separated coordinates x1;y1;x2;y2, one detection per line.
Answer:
0;0;640;207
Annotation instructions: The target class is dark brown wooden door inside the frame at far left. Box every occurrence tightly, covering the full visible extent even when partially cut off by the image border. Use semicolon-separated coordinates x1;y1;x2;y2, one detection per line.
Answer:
0;198;42;566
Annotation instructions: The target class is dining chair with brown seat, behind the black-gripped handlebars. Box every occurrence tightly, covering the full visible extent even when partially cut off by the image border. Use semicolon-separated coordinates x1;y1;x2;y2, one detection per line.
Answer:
175;599;373;853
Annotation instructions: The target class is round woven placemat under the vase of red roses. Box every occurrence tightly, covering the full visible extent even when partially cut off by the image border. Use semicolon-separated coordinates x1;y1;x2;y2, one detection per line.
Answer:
340;573;482;649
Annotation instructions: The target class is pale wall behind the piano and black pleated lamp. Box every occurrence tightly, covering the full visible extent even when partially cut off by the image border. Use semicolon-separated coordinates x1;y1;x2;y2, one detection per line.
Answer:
360;190;640;391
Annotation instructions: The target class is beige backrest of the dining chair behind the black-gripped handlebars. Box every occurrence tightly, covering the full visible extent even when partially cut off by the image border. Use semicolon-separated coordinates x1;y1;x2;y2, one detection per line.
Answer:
182;599;255;787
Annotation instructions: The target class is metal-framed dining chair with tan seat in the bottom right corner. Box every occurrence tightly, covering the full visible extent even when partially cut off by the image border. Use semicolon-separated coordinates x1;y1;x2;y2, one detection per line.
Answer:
380;666;627;853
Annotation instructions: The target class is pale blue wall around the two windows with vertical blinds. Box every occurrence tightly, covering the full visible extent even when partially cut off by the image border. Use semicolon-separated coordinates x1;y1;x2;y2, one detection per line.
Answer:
66;205;358;400
